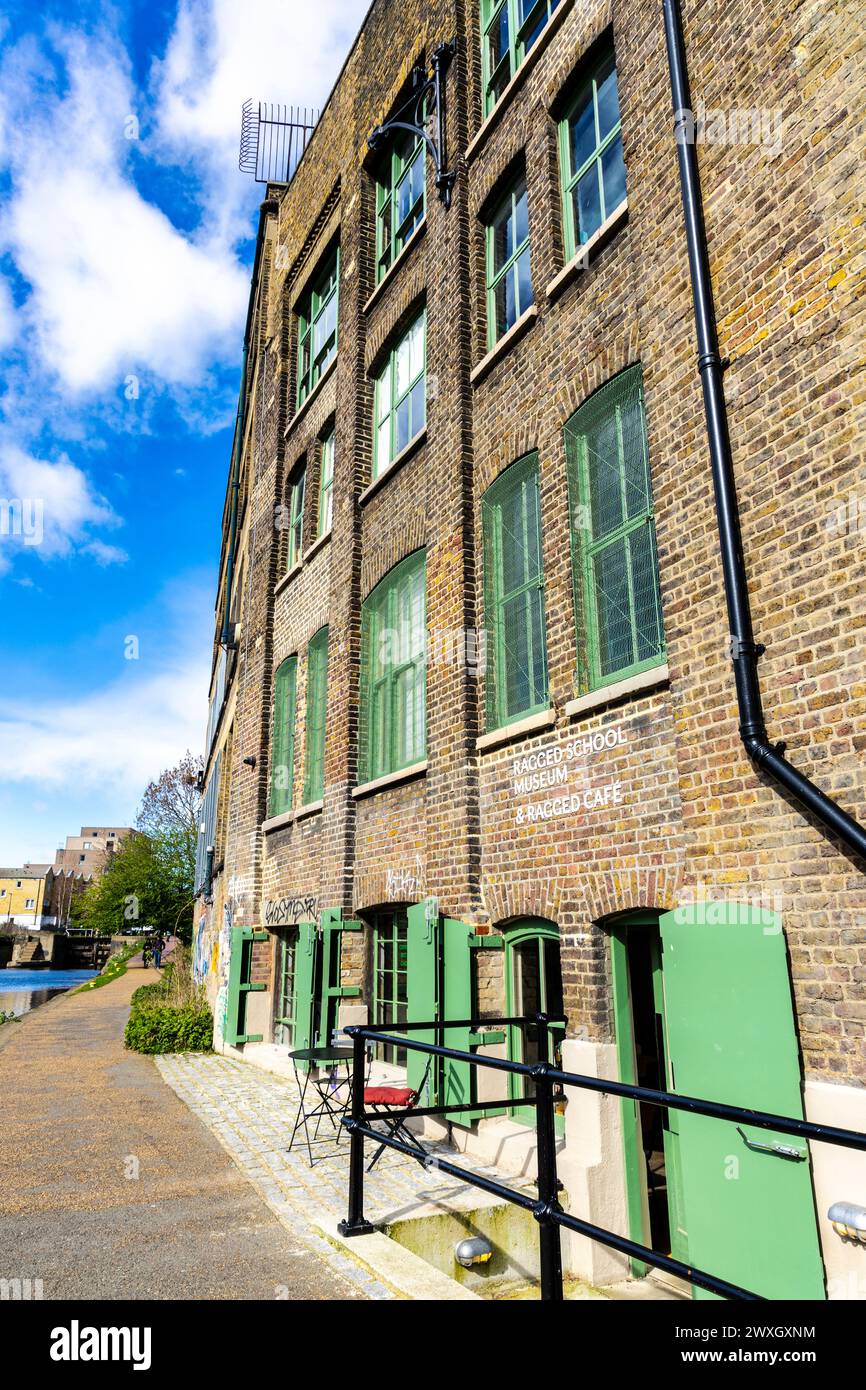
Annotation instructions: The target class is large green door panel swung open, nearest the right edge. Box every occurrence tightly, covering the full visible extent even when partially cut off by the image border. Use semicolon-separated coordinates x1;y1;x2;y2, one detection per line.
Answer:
659;902;824;1300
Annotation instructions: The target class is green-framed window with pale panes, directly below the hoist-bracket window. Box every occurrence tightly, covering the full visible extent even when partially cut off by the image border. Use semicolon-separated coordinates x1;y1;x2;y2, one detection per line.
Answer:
373;309;427;478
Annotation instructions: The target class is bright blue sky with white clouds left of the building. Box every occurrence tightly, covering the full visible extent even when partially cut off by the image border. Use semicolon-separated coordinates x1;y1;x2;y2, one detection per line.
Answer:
0;0;368;865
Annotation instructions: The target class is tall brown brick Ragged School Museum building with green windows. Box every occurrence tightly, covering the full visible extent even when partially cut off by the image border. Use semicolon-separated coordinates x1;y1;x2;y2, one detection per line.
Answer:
196;0;866;1298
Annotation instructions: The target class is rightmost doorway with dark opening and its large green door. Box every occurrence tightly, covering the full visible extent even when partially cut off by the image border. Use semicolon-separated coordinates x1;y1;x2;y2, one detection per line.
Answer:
613;902;824;1300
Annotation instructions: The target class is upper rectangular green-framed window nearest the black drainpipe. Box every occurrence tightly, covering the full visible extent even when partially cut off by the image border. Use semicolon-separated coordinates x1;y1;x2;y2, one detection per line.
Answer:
559;49;627;260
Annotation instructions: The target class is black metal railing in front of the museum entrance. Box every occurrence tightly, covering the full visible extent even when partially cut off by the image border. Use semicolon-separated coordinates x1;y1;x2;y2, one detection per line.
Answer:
339;1013;866;1302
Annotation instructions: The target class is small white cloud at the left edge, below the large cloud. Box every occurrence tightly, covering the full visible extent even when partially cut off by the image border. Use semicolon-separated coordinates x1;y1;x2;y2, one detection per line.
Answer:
0;442;126;570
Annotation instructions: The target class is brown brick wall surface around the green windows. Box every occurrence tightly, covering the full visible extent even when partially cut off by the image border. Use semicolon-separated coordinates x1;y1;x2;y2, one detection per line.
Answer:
200;0;866;1083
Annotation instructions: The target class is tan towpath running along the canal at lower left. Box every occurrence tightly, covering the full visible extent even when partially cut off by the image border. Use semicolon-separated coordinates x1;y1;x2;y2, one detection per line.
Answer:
0;969;392;1300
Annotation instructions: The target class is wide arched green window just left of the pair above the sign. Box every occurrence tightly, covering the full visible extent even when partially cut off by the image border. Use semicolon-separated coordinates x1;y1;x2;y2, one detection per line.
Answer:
359;550;427;783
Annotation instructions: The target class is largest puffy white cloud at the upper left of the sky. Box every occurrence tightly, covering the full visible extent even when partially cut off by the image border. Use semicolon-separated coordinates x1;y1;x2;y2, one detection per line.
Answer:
0;31;246;393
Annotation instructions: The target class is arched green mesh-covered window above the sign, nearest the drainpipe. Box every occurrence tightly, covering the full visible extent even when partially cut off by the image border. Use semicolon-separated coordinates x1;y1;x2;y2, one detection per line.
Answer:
566;364;666;691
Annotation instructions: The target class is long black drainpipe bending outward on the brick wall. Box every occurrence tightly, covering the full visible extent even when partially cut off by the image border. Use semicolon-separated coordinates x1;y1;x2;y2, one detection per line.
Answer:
663;0;866;858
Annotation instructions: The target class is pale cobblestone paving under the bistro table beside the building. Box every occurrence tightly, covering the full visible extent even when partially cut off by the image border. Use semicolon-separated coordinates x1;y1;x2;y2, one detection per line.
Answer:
157;1052;530;1297
